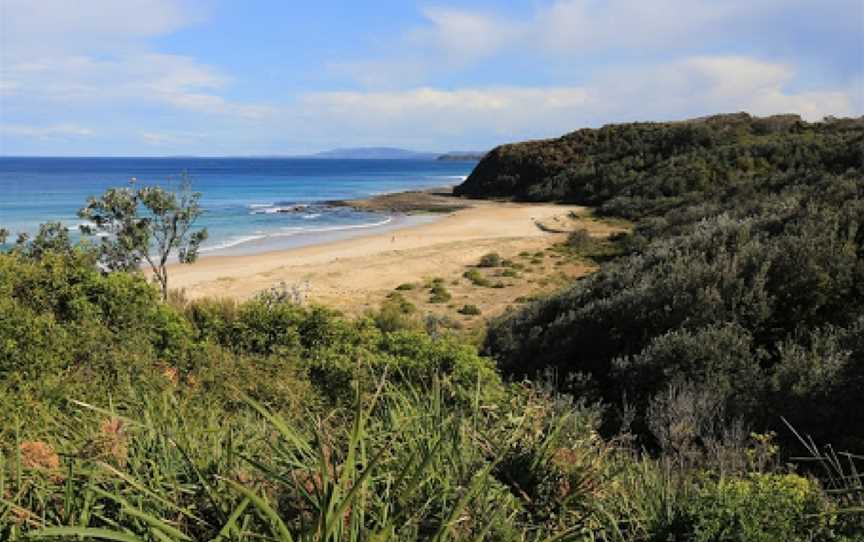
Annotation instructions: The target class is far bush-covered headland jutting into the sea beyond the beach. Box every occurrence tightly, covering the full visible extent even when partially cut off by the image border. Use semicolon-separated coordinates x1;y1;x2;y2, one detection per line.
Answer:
455;113;864;218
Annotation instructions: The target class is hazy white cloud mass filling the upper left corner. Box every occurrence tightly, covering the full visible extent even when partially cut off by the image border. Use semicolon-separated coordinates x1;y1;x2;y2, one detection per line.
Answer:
0;0;271;120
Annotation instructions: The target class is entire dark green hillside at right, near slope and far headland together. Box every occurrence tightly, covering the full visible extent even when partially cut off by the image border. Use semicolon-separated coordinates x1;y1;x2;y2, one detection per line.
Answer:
457;114;864;450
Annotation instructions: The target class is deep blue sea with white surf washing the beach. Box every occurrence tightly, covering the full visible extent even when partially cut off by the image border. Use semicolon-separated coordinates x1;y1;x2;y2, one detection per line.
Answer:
0;157;474;254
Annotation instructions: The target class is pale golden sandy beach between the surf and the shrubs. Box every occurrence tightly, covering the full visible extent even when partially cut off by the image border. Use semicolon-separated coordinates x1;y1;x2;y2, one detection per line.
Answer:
170;200;621;314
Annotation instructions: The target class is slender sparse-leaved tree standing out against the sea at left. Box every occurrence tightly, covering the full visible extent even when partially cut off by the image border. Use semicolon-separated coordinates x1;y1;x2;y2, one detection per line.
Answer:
78;174;207;300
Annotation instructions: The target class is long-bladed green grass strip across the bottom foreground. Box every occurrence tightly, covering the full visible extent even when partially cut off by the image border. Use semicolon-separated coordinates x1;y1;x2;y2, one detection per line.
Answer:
0;375;861;542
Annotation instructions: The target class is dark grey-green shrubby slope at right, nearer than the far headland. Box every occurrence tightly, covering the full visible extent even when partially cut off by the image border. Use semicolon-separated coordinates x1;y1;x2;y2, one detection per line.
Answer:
486;189;864;449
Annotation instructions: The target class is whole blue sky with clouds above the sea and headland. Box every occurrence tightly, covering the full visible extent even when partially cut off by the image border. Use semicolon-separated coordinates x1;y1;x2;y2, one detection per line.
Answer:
0;0;864;156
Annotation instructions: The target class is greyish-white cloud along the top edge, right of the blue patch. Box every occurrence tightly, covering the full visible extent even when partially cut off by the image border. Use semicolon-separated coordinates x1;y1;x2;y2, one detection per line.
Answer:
339;0;862;88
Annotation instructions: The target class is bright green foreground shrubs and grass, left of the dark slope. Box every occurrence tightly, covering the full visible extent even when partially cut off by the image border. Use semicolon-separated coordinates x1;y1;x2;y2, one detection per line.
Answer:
0;236;855;541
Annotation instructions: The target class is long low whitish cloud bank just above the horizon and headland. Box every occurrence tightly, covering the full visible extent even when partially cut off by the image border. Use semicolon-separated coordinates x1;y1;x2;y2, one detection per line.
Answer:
294;56;860;151
